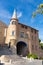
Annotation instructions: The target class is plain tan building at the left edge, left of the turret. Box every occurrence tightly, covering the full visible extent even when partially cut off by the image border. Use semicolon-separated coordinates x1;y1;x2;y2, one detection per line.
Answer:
0;21;7;45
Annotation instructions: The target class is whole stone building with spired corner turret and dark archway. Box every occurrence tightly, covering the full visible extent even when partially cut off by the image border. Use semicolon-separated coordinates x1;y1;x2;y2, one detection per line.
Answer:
0;11;40;55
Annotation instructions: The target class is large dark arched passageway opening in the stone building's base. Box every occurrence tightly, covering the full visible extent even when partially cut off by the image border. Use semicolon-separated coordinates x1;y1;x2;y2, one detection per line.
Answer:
16;41;28;56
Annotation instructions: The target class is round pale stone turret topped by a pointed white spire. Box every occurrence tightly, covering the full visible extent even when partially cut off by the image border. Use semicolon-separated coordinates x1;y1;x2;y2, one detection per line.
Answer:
6;10;18;45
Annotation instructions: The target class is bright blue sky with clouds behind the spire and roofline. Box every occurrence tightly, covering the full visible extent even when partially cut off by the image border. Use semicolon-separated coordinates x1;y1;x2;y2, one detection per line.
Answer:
0;0;43;41
